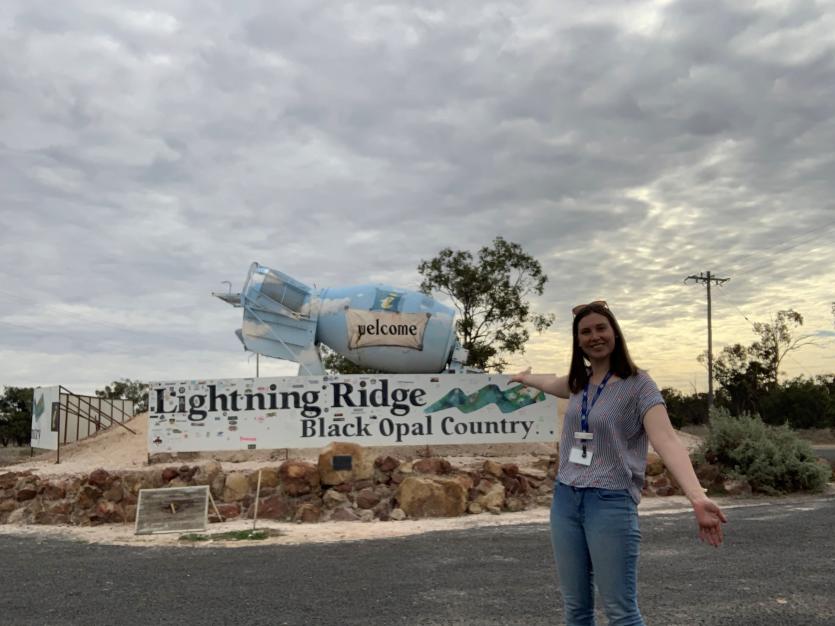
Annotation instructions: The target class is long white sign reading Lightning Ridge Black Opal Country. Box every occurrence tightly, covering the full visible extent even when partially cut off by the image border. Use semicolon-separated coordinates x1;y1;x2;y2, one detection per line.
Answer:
148;374;557;453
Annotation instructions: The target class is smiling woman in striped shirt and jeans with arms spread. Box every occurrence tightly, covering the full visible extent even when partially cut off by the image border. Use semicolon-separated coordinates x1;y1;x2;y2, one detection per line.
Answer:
511;301;727;626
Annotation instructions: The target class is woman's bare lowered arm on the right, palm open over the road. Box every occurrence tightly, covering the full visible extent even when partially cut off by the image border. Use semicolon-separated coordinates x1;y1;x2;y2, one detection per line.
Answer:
644;404;728;547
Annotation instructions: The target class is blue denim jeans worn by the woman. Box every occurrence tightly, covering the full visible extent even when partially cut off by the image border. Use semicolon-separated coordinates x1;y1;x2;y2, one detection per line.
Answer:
551;482;644;626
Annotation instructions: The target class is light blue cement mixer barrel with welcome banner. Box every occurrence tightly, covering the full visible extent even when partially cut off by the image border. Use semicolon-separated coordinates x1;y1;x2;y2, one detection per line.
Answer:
212;263;470;375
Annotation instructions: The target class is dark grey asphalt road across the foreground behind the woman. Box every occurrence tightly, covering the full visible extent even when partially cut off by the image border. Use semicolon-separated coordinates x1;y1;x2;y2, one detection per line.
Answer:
0;497;835;626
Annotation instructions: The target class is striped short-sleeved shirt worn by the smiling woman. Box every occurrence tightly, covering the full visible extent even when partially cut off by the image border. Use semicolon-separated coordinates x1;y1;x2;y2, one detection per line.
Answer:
557;370;664;504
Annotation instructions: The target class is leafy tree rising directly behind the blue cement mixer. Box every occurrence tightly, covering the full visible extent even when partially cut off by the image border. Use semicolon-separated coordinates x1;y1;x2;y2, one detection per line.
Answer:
417;237;554;372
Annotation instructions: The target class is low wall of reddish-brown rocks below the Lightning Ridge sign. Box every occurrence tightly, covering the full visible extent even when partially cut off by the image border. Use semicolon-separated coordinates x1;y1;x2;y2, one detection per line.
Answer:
0;444;696;526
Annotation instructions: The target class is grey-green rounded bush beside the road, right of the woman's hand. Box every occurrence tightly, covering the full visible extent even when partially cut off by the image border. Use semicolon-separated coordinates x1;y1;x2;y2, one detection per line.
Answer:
697;409;830;494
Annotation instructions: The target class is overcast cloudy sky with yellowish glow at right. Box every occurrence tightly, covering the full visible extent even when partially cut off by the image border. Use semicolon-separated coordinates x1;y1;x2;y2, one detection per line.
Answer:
0;0;835;393
